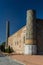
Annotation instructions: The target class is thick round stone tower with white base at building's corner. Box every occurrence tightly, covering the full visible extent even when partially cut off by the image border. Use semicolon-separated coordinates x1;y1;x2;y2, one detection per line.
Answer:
24;10;37;55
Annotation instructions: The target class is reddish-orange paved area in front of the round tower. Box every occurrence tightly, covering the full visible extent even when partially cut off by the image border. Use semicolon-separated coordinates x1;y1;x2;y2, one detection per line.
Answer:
10;55;43;65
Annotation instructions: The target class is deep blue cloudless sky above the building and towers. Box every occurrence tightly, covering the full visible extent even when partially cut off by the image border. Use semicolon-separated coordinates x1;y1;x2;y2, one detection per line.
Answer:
0;0;43;43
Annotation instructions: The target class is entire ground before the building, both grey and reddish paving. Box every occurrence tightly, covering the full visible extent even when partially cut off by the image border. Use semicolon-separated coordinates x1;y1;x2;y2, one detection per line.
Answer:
0;53;43;65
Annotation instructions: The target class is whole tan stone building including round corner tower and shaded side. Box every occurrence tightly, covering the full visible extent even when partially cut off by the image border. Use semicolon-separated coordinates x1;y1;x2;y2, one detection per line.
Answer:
8;10;43;55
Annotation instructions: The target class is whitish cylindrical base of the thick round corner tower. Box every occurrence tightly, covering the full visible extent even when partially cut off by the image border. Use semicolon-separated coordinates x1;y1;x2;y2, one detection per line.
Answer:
24;45;37;55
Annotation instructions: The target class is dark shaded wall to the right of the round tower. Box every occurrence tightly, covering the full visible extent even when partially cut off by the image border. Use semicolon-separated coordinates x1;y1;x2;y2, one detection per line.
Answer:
36;19;43;55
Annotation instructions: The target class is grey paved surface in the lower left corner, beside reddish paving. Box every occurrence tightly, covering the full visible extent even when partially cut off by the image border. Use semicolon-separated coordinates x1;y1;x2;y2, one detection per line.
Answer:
0;56;23;65
